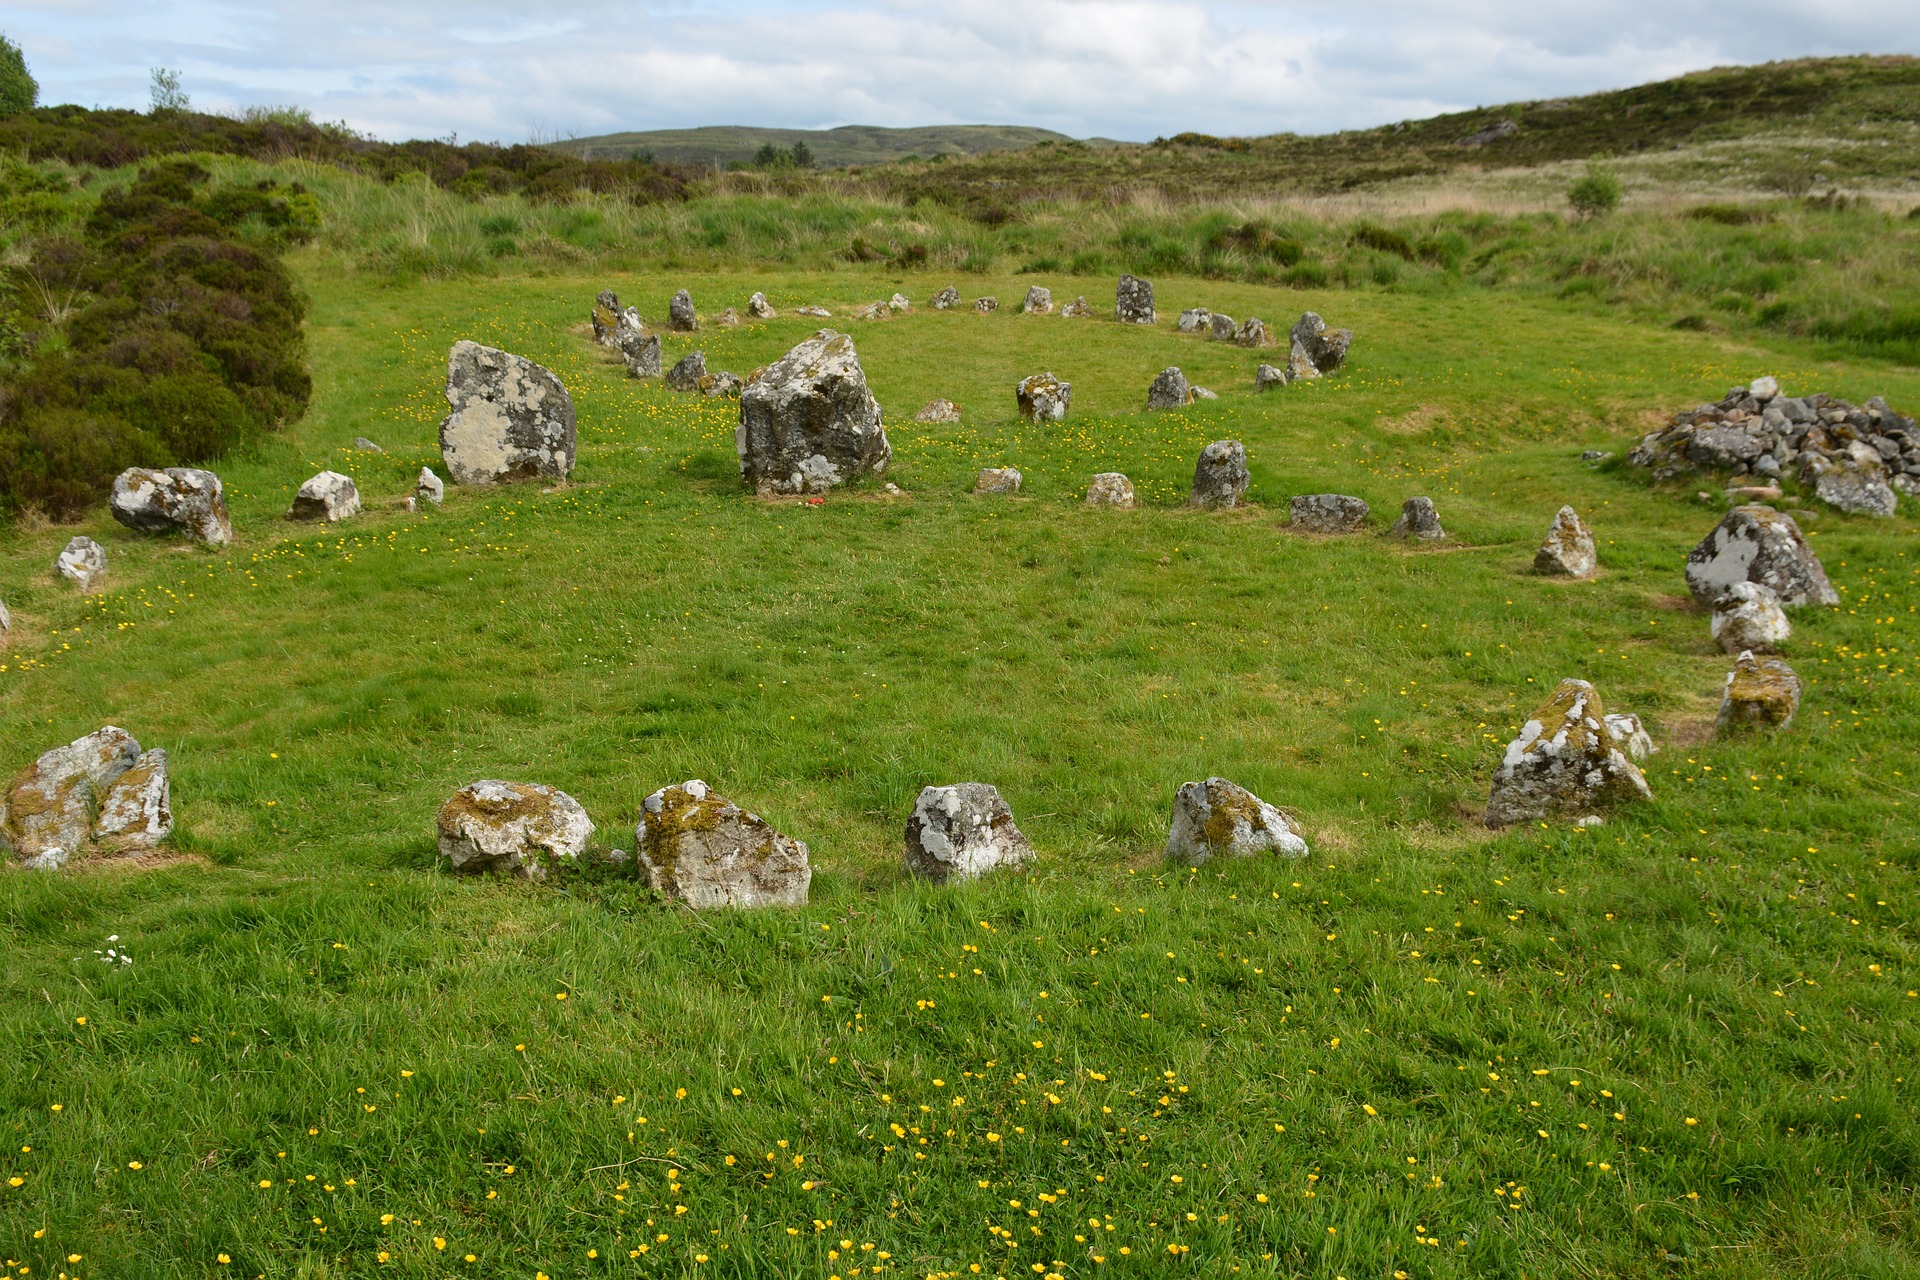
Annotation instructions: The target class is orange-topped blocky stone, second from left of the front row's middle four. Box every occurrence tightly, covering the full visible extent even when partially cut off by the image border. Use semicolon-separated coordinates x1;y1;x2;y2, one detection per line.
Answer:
634;777;814;912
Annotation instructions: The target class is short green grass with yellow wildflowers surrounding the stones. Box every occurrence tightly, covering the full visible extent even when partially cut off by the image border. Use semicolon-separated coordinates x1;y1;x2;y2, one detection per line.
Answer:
0;255;1920;1280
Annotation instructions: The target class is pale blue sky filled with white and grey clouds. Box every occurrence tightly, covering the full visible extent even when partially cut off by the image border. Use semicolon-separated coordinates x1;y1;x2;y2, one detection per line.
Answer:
0;0;1920;142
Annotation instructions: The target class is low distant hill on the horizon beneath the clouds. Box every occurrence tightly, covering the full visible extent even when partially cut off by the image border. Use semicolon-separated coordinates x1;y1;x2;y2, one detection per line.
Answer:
553;125;1112;169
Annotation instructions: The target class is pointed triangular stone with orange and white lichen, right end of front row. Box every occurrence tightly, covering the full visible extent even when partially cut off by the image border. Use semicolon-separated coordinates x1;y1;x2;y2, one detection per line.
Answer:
1486;679;1653;827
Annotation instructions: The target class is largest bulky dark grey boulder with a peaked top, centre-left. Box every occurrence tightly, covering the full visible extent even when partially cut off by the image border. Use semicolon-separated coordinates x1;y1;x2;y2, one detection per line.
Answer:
733;328;893;493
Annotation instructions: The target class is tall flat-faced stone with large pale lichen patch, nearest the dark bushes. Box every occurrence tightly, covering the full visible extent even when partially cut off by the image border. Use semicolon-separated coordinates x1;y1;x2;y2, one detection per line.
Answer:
440;342;574;484
